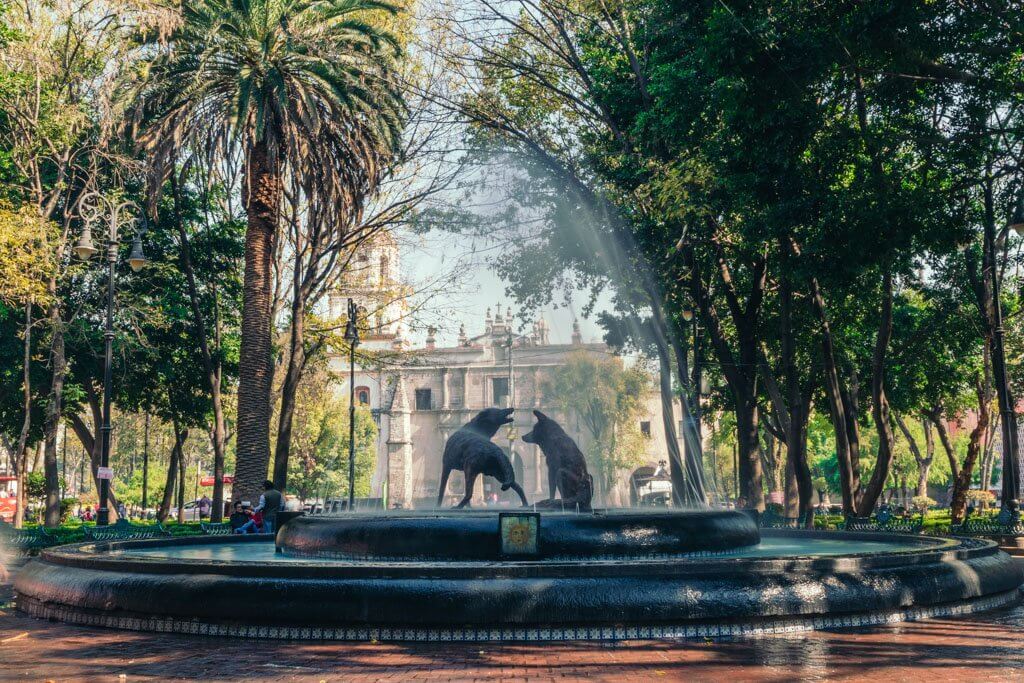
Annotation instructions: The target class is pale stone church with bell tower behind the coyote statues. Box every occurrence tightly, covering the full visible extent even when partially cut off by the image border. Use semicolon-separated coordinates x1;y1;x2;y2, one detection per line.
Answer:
332;239;679;508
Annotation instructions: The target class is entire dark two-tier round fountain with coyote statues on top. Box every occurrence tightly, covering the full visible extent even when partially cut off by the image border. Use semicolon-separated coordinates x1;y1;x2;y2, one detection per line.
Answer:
14;409;1024;641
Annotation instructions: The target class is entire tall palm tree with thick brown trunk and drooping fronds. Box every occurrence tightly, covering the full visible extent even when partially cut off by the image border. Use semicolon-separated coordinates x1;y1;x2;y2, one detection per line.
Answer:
139;0;404;498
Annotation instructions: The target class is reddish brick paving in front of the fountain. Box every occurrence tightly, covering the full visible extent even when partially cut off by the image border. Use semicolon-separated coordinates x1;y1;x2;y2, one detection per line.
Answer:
0;573;1024;683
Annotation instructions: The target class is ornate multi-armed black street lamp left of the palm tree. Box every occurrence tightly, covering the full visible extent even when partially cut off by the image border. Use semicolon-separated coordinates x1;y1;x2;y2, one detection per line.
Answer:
75;191;146;526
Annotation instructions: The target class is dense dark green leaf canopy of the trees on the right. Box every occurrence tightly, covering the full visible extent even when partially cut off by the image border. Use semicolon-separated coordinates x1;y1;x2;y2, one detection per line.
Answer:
453;0;1024;511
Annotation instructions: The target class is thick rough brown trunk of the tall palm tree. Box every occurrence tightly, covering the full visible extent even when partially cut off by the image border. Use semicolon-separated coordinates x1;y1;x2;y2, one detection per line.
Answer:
234;142;281;500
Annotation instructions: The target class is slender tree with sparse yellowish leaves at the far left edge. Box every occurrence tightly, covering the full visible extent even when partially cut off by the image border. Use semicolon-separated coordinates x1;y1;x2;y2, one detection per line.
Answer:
0;0;151;524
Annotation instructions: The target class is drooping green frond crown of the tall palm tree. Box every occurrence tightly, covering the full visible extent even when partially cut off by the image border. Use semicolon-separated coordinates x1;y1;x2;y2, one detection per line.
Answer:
138;0;404;224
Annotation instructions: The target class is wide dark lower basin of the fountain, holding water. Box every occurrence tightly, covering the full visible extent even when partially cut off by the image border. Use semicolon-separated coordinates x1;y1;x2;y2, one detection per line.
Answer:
14;513;1024;641
